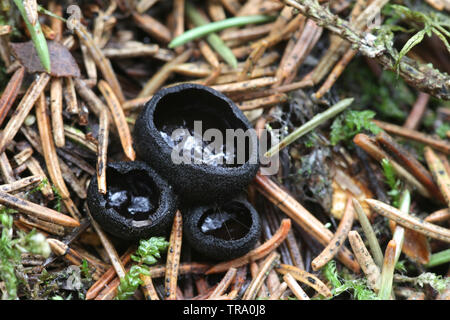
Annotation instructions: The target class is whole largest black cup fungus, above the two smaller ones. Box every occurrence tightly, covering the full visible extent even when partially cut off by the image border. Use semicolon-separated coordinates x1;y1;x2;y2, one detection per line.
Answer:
134;84;259;204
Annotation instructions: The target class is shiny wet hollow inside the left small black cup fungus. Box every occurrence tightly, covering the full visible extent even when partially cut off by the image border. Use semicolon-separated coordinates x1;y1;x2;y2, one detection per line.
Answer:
104;167;161;221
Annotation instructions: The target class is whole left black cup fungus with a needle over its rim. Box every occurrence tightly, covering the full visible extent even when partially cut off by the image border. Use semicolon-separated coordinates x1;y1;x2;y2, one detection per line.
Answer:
87;161;177;240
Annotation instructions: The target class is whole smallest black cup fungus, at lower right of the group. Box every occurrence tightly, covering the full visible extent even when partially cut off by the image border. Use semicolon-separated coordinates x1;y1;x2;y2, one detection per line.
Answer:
183;199;261;261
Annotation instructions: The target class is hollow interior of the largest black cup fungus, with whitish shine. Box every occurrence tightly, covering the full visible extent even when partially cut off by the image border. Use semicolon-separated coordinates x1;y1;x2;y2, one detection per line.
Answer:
153;88;251;168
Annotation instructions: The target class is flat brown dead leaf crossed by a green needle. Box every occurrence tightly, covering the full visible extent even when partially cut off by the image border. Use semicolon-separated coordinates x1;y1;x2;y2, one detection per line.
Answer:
10;41;80;77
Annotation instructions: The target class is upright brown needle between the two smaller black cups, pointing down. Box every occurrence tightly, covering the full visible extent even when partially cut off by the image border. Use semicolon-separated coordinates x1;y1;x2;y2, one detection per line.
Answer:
164;210;183;300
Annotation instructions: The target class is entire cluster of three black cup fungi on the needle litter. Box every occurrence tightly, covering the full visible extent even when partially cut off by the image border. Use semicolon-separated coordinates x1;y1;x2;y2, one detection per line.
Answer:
88;84;261;260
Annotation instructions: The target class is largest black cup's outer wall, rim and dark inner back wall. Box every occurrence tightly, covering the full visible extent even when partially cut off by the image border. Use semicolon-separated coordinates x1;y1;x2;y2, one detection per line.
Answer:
134;84;259;204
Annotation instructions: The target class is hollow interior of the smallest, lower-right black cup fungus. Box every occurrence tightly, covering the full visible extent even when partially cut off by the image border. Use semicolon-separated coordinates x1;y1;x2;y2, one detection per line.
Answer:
198;202;252;241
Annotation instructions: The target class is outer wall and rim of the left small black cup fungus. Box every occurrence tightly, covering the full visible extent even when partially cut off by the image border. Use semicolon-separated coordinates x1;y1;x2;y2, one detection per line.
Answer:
87;161;177;240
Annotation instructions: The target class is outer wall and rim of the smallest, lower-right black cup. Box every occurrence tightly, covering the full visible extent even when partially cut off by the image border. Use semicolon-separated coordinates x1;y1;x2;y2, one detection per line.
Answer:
183;199;261;261
